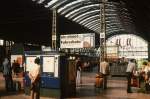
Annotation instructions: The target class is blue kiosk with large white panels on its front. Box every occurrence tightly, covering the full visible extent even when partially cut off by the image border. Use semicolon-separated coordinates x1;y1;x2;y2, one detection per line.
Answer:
24;51;76;98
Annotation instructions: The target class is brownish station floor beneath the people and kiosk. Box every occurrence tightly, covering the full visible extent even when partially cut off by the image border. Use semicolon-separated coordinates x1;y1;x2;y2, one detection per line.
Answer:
0;72;150;99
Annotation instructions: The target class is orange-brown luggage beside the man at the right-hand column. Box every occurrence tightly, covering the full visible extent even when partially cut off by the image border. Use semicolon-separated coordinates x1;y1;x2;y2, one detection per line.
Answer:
95;74;103;88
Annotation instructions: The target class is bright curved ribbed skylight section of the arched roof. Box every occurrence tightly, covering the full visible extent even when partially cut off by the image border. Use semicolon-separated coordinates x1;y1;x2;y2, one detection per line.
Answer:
44;0;131;34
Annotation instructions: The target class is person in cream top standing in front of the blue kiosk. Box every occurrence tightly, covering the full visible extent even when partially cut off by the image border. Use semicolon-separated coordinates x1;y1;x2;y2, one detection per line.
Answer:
29;57;40;99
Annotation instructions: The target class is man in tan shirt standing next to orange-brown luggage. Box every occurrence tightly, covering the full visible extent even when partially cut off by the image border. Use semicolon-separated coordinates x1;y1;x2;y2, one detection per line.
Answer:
100;59;110;89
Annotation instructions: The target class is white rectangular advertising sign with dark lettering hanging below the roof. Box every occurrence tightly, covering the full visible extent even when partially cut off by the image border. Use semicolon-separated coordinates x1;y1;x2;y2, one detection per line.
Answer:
60;33;95;48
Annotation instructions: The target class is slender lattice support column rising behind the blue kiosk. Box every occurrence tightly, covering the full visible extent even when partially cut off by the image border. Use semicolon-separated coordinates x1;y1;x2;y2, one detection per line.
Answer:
52;9;57;50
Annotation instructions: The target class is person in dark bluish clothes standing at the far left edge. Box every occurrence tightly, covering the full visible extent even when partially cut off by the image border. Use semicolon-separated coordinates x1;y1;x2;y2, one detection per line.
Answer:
3;58;13;91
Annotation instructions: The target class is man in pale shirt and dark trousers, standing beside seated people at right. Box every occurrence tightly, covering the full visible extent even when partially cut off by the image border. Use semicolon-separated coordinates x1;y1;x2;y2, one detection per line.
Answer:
126;59;136;93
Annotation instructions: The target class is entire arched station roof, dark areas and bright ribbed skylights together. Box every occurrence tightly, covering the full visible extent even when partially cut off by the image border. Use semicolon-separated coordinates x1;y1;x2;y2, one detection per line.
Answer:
0;0;150;44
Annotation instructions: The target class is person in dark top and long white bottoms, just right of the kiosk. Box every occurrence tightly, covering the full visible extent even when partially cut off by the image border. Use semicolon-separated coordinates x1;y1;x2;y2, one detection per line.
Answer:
76;57;82;86
